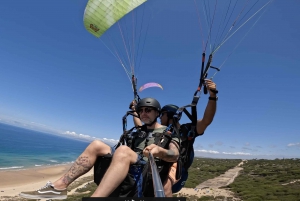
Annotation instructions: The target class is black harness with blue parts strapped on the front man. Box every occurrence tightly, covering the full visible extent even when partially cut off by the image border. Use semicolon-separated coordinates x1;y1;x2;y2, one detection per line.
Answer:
94;111;173;197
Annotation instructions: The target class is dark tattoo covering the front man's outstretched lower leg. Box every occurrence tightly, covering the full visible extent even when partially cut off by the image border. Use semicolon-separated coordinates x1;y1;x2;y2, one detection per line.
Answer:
62;156;93;185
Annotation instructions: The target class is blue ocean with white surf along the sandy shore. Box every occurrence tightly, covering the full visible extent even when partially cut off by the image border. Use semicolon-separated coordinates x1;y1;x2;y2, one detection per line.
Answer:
0;123;89;171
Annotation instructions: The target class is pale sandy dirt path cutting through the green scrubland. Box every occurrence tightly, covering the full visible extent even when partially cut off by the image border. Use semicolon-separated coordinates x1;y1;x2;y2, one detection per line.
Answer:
178;161;245;201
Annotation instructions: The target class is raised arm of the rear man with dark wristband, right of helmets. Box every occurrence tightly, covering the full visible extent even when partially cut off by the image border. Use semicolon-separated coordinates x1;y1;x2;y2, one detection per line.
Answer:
197;80;217;134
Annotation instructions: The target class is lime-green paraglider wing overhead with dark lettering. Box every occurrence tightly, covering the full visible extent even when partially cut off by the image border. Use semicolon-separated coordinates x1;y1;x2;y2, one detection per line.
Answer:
83;0;147;38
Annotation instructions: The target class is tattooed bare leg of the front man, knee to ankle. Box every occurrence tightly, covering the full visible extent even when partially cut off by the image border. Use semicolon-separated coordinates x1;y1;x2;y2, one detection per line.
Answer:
53;140;111;189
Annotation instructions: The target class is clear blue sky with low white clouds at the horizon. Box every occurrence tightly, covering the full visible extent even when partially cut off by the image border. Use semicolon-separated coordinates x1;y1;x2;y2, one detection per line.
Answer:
0;0;300;158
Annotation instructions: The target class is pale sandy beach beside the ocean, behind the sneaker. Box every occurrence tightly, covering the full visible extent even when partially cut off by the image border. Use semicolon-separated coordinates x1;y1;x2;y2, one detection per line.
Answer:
0;164;94;200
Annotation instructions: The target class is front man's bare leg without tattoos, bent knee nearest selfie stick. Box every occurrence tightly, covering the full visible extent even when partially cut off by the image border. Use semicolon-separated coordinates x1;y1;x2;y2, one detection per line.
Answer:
92;146;137;197
